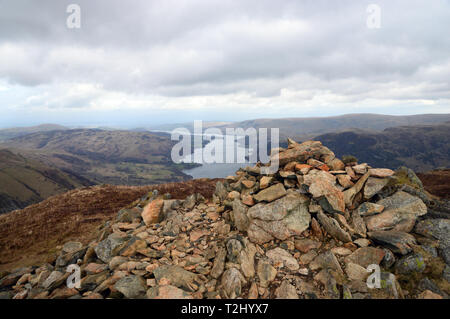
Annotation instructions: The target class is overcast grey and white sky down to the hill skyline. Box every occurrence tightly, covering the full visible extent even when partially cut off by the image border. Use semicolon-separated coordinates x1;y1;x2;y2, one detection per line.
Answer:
0;0;450;127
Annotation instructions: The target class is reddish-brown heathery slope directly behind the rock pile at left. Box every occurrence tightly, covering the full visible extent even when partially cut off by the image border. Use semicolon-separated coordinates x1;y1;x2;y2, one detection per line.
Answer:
0;179;217;271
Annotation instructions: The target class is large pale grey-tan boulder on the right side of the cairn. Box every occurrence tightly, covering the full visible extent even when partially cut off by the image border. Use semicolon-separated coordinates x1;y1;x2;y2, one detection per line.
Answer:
366;191;427;232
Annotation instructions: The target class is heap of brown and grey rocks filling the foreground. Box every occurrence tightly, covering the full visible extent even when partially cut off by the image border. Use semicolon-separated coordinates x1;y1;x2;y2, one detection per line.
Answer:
0;139;450;299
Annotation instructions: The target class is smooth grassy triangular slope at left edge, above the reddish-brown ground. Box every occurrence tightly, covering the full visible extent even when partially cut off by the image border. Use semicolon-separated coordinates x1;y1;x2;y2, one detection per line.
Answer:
0;149;93;213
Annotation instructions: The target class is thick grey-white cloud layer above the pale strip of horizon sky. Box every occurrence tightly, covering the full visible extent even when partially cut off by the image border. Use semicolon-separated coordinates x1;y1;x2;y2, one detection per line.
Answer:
0;0;450;112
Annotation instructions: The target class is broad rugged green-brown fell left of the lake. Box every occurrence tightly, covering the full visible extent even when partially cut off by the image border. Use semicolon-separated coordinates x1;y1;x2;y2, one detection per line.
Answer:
0;129;195;185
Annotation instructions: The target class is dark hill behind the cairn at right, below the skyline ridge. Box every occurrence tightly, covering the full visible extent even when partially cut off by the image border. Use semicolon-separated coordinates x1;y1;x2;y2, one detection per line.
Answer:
314;122;450;172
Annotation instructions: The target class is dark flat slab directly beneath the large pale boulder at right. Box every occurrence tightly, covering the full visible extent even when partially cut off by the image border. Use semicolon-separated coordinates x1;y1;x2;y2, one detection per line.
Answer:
368;230;417;255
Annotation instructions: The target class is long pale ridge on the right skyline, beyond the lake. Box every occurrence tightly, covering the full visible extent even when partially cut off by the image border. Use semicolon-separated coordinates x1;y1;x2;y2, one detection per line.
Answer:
221;114;450;140
